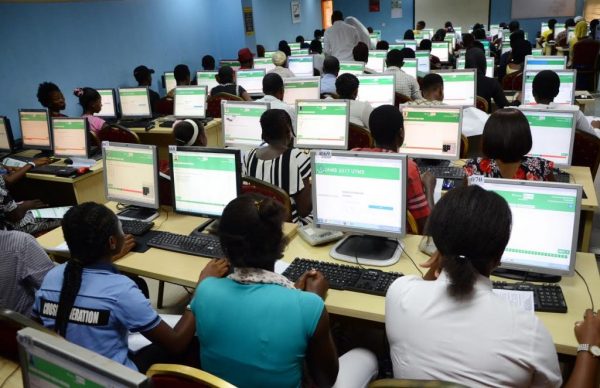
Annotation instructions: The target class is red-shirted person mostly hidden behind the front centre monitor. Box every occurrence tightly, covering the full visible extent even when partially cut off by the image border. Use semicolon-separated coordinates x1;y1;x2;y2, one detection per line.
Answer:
354;105;435;230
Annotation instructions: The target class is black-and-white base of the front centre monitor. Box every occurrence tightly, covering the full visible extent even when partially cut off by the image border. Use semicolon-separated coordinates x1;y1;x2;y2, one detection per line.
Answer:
329;235;403;267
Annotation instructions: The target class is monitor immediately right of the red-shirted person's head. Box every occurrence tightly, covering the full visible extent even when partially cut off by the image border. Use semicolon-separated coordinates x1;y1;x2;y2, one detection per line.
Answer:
398;105;462;160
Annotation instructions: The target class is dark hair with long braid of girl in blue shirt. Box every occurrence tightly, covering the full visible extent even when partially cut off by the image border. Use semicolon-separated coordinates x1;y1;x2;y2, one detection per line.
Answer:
54;202;121;337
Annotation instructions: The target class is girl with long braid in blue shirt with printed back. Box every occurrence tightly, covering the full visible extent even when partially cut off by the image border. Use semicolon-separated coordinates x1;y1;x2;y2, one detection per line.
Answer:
33;202;227;370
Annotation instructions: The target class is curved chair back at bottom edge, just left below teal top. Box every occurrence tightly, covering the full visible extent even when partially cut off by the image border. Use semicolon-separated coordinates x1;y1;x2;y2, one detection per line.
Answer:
146;364;236;388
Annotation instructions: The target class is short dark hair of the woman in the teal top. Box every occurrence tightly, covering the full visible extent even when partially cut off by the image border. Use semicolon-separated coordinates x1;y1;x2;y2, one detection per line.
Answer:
219;194;286;270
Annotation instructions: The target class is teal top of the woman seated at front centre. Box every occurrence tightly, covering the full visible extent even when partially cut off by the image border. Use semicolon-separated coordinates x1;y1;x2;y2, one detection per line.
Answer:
191;278;324;387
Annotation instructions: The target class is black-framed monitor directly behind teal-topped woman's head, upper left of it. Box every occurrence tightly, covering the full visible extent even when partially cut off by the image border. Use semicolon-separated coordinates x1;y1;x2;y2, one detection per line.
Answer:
169;146;241;217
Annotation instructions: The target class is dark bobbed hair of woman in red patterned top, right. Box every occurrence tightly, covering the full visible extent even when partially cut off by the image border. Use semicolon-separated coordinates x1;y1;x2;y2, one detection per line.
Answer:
481;108;532;163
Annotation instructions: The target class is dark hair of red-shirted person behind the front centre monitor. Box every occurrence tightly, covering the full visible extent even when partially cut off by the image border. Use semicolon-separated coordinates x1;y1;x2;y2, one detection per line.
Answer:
369;105;404;146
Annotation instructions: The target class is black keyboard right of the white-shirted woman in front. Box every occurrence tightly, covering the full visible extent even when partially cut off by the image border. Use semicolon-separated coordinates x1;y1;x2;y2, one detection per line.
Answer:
493;282;567;314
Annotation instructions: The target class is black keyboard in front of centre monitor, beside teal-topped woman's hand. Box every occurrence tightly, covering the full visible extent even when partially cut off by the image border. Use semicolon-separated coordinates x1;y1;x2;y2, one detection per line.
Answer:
283;257;403;296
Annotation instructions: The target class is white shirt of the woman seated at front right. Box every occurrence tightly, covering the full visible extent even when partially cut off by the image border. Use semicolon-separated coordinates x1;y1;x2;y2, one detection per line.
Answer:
385;272;562;387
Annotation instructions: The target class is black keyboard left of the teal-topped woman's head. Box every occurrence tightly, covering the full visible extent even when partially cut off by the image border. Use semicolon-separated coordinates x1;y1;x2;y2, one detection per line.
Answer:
147;232;225;259
